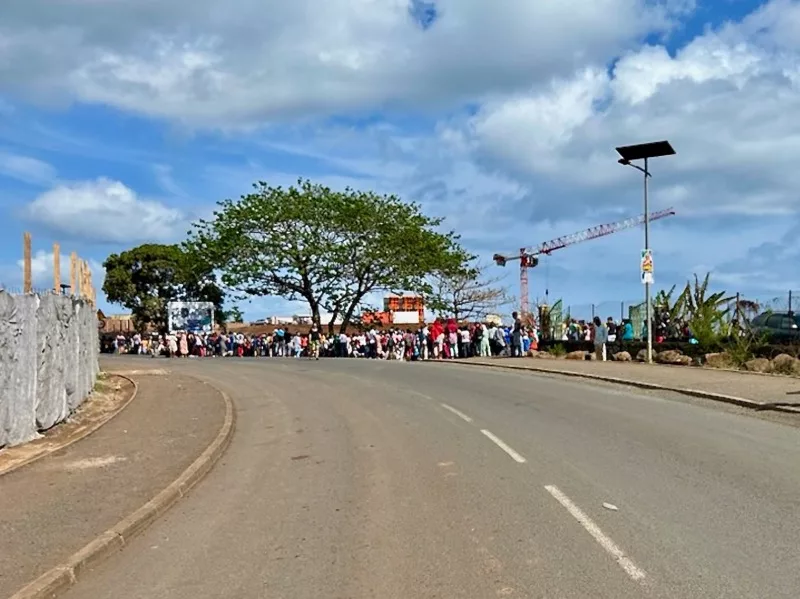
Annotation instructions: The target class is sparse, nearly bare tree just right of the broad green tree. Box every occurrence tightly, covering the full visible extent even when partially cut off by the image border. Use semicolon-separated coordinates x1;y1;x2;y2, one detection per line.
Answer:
426;261;513;322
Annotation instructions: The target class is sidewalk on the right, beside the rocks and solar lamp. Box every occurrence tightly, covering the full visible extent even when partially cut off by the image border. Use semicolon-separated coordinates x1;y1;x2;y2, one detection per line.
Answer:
446;358;800;407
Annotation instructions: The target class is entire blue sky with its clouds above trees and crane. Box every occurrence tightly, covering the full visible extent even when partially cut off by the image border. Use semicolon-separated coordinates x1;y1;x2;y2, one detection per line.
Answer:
0;0;800;320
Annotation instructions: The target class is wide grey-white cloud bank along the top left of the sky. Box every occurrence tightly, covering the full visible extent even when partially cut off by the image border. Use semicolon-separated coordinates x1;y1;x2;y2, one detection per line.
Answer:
0;0;693;126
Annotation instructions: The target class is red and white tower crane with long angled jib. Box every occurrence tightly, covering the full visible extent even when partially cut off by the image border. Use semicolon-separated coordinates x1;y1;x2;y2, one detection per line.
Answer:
492;208;675;315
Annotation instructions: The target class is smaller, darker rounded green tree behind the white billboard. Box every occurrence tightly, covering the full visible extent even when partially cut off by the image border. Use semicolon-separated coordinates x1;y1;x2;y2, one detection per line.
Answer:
103;243;225;330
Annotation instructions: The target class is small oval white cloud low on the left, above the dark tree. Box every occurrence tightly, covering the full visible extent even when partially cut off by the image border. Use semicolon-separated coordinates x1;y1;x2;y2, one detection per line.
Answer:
25;178;186;244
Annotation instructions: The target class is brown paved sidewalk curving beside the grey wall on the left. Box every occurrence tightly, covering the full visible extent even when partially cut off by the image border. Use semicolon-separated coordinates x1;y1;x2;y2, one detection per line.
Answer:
0;374;225;598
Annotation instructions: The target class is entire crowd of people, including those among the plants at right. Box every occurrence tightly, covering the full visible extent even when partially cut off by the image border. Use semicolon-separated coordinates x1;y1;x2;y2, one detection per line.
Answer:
102;312;691;361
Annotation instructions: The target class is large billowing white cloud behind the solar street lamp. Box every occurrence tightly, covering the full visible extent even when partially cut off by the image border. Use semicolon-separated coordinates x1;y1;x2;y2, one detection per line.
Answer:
463;0;800;216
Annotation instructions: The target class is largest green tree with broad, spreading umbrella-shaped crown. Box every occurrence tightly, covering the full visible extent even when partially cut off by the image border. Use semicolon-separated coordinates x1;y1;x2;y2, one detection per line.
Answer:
187;179;469;331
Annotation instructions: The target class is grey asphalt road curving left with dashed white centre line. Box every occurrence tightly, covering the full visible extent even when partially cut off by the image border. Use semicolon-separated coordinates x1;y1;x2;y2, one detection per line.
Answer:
66;359;800;599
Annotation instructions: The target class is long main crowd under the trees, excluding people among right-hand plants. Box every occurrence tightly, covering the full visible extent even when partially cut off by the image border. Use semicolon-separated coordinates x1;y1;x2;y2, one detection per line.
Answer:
104;312;538;361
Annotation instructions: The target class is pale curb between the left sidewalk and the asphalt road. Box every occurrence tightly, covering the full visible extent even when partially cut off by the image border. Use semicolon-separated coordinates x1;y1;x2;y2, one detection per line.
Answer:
8;381;236;599
